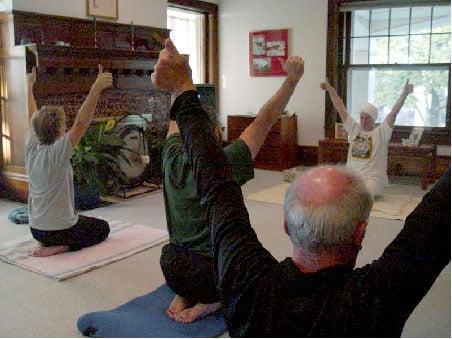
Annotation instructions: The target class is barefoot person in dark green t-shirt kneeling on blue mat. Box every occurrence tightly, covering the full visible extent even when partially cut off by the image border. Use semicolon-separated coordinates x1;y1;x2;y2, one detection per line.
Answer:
160;56;304;322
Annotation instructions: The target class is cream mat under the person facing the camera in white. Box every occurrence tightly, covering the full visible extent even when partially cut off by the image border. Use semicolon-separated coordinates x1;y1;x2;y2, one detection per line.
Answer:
247;183;422;220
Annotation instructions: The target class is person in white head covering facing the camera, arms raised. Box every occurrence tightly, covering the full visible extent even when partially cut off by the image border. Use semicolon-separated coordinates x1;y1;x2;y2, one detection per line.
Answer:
320;80;413;197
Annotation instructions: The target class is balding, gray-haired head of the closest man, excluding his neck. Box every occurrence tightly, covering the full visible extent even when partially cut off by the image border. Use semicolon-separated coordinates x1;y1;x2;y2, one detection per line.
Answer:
284;166;373;254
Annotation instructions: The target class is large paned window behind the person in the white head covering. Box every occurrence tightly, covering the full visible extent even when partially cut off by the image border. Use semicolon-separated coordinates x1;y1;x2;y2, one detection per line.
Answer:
339;5;451;131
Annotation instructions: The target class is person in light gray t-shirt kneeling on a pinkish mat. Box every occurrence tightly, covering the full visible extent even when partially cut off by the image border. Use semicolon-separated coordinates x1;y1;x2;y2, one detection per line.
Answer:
25;65;112;257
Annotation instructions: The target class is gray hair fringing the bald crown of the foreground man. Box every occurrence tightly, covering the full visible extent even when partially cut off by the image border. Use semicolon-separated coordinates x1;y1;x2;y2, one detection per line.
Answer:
284;166;373;254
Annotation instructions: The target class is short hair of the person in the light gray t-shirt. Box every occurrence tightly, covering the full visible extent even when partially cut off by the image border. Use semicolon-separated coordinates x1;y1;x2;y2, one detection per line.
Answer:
31;106;66;145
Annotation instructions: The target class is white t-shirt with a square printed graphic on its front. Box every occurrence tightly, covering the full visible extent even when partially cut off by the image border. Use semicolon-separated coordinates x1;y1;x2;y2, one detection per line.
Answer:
344;116;393;185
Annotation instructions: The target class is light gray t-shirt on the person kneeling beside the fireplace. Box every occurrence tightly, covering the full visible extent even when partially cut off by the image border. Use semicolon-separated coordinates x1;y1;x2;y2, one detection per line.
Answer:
25;127;78;231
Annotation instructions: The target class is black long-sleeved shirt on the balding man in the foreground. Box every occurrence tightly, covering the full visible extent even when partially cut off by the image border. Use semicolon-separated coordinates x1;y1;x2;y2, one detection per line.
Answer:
171;91;450;337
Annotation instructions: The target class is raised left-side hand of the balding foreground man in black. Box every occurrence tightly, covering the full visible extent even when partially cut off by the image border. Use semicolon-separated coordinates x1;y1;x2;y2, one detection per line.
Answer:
151;39;194;95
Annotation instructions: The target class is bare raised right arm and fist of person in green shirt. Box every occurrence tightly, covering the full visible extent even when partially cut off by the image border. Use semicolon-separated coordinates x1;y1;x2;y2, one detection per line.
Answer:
239;56;304;159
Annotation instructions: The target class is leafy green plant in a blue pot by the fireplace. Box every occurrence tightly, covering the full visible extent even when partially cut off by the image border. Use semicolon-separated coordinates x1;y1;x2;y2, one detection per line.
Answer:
71;121;130;209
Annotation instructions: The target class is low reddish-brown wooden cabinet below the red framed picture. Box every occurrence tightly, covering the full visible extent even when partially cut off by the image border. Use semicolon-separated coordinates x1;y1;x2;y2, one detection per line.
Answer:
228;115;297;171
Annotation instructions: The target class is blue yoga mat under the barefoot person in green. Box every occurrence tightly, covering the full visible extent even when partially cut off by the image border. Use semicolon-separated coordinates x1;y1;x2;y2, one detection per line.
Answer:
77;284;227;338
